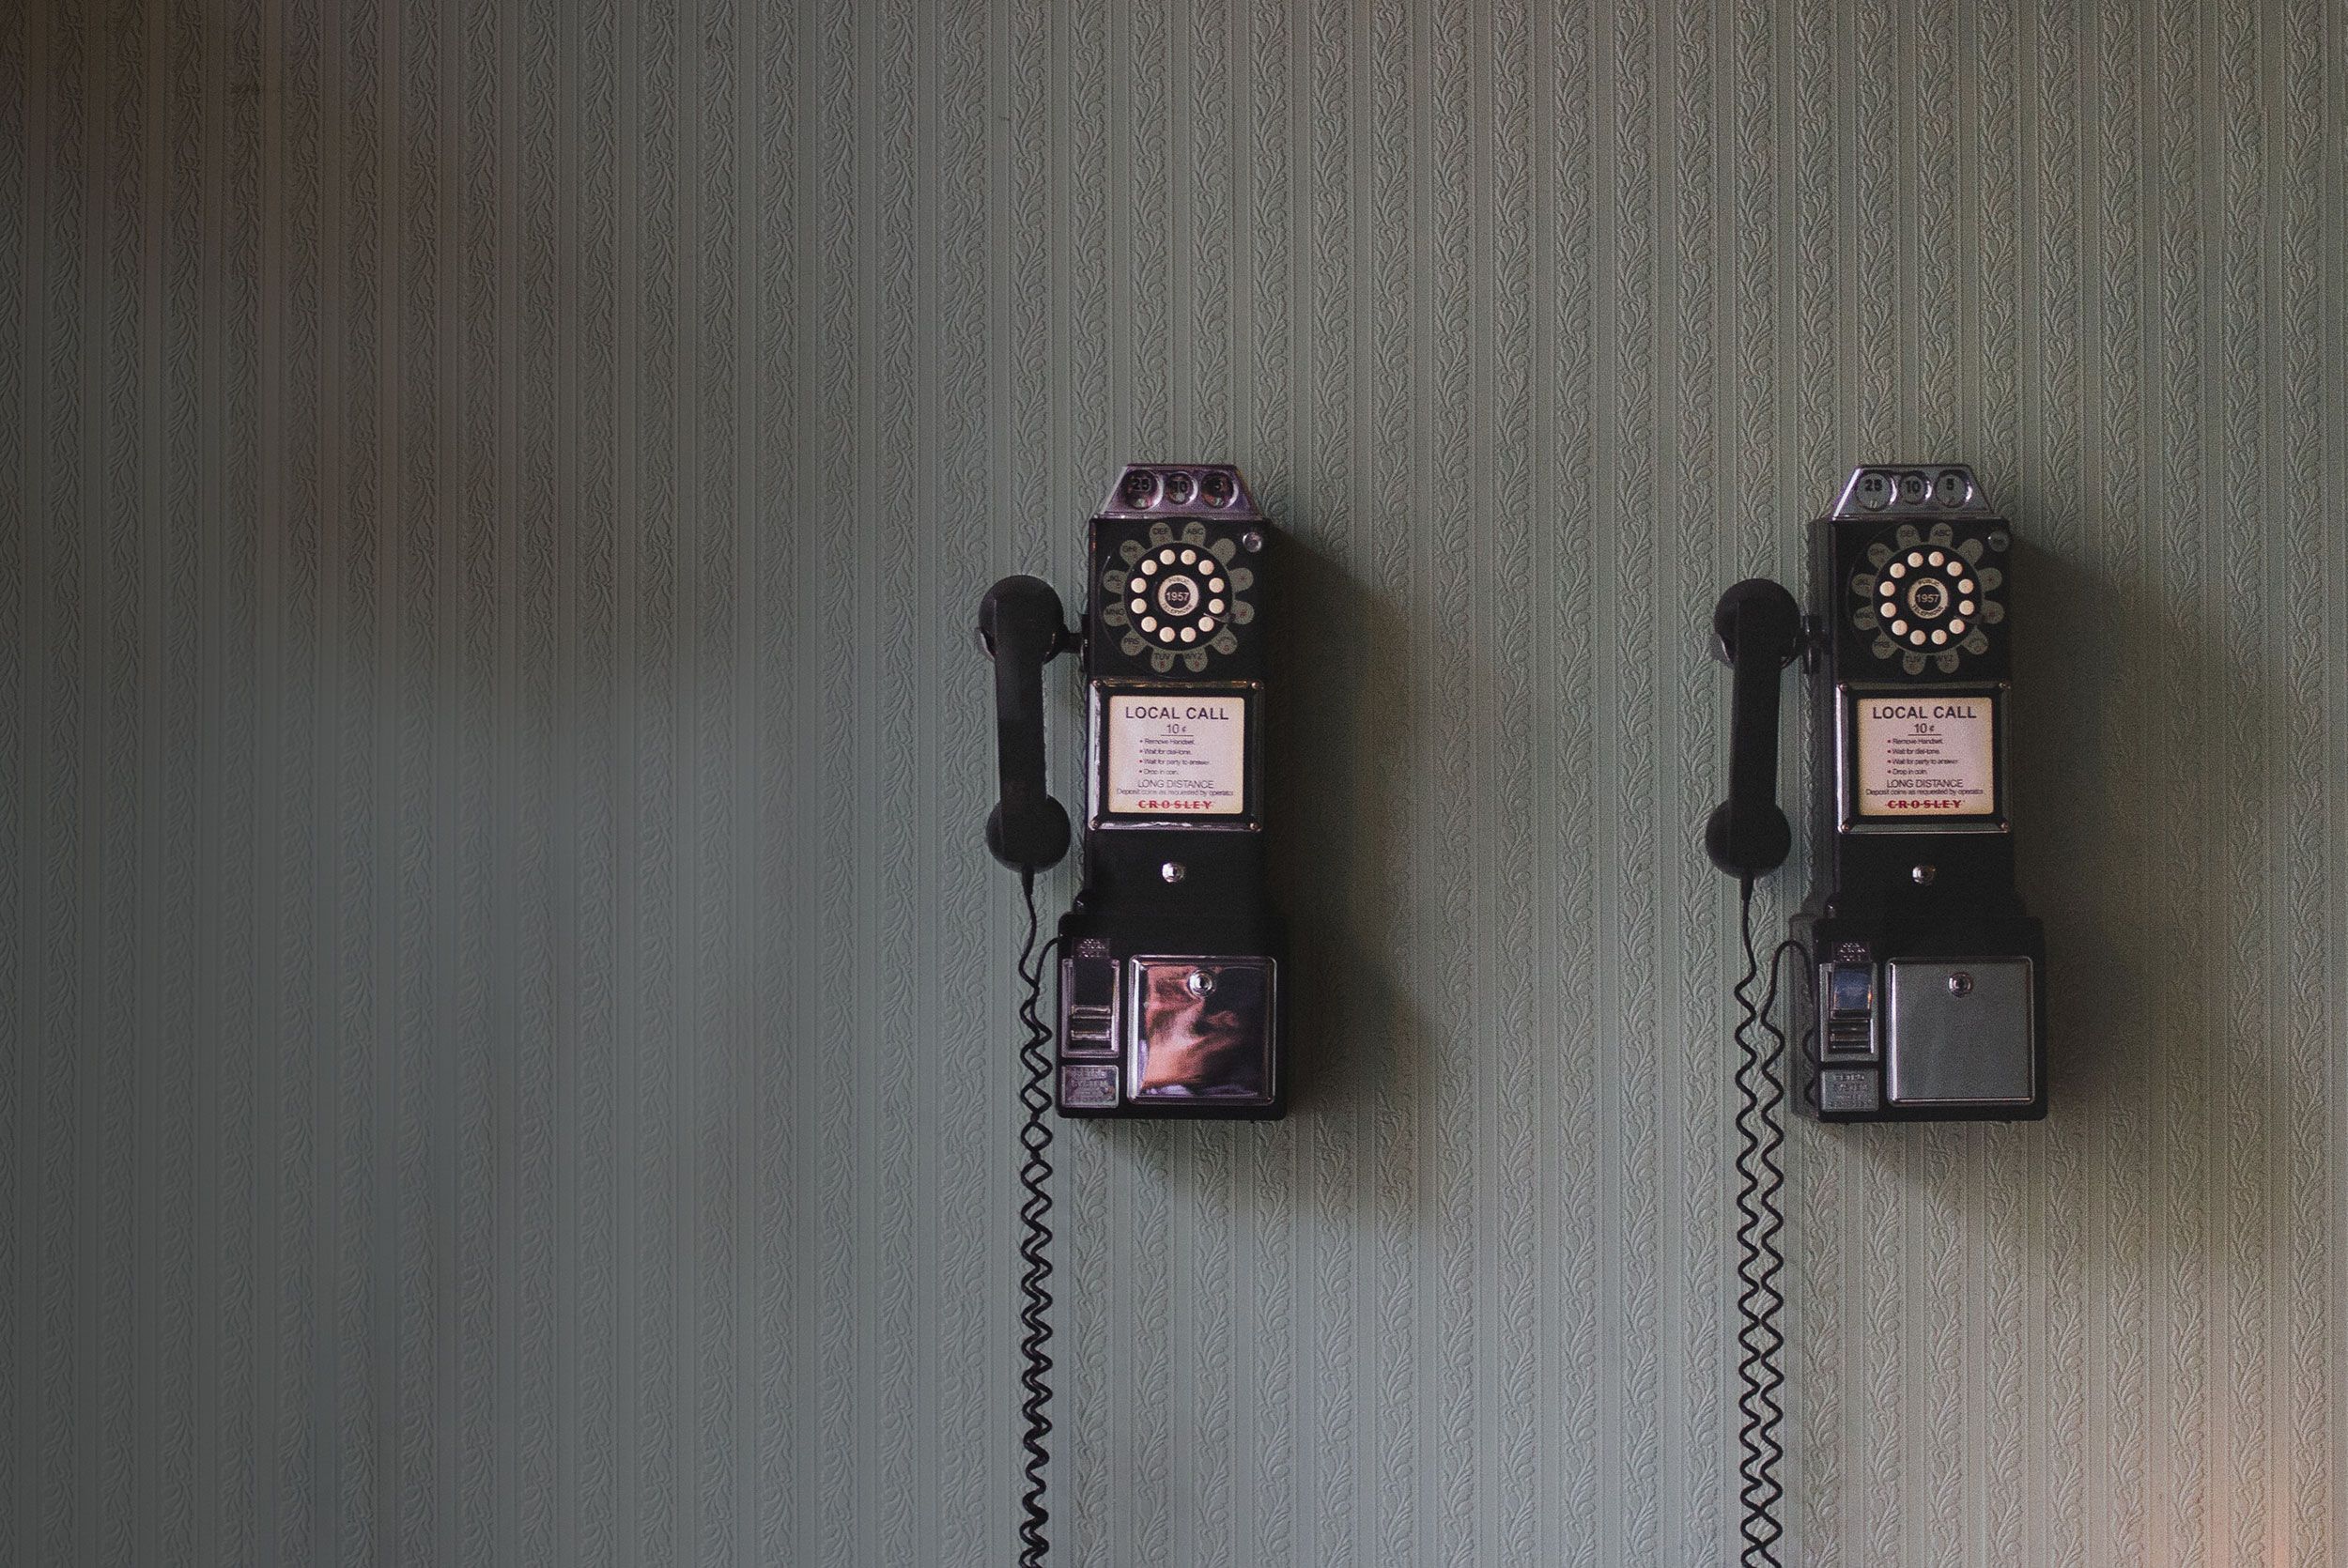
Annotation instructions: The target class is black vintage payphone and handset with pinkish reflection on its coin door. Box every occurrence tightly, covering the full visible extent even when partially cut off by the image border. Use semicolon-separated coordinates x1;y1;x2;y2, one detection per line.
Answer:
980;463;1285;1120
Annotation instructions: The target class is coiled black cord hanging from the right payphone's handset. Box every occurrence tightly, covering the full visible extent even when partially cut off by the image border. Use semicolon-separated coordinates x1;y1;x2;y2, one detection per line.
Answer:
1736;878;1806;1568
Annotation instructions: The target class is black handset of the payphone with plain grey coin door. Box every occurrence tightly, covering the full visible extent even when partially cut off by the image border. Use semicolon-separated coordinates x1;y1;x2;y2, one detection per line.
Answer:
1705;577;1801;881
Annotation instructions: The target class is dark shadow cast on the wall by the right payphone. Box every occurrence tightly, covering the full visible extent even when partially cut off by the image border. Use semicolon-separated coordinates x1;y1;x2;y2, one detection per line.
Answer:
1789;512;2287;1296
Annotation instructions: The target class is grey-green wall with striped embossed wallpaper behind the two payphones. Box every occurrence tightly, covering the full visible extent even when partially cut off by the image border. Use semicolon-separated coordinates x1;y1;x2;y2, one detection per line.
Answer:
0;0;2348;1568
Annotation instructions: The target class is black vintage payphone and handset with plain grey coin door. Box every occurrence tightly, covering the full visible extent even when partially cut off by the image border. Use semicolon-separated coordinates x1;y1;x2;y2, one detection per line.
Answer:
1705;465;2047;1122
